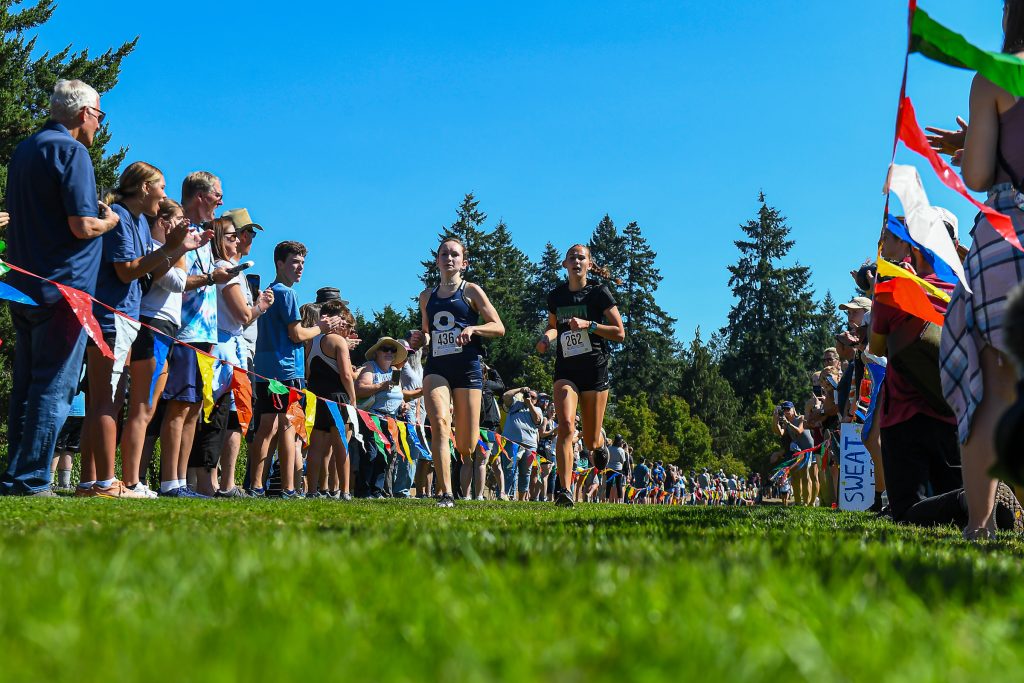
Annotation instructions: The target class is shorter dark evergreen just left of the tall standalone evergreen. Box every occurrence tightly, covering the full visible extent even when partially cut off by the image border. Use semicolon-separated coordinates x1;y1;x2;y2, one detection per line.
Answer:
679;328;742;455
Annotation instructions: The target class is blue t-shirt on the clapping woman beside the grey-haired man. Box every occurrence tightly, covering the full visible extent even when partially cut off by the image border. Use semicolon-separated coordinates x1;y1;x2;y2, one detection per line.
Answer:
92;204;153;333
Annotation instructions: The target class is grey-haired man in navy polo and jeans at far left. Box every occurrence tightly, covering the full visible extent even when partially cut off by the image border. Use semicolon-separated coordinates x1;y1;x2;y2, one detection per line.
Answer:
0;81;118;496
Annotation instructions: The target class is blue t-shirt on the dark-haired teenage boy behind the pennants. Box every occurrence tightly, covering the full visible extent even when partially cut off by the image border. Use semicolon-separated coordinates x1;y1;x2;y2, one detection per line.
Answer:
256;283;306;381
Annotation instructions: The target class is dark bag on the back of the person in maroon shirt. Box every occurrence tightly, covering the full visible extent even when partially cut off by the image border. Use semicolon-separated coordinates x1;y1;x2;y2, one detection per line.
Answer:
886;319;953;417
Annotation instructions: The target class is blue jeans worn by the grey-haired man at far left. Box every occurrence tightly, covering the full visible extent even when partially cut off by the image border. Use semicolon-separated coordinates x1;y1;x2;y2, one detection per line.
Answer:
0;300;86;496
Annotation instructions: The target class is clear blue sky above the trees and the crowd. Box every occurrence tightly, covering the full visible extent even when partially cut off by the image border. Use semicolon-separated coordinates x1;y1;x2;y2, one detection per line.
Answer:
29;0;1001;340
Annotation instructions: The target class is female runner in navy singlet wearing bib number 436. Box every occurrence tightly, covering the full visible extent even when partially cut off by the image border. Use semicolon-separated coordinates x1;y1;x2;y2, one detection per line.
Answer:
409;238;505;508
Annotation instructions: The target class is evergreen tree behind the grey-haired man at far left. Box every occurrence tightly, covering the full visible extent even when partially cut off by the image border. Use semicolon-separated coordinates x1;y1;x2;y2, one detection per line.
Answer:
0;0;138;428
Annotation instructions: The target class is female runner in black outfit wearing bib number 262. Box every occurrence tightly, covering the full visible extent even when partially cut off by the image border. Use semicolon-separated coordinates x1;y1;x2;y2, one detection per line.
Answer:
537;245;626;508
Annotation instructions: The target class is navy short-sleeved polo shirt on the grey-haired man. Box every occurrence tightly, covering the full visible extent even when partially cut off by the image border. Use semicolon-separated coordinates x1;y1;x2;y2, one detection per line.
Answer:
4;121;102;304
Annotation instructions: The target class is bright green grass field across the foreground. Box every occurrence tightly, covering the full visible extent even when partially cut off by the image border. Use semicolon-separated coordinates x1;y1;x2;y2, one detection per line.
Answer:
0;499;1024;683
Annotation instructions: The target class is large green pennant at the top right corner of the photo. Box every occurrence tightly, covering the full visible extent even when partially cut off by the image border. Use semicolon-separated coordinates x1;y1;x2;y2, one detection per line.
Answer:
910;7;1024;97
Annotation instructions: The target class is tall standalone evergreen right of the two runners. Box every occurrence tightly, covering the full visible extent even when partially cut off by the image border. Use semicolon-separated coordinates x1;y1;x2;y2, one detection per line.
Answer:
722;193;817;402
